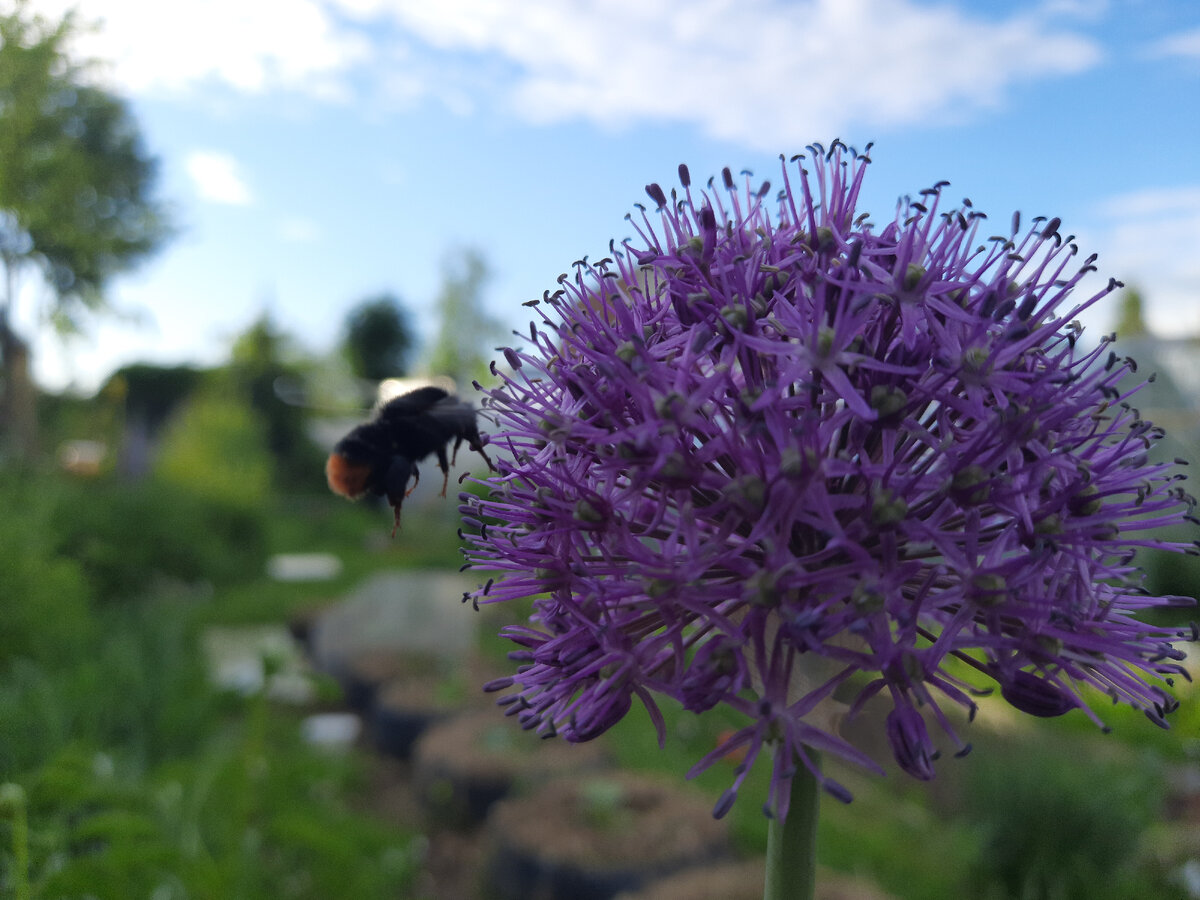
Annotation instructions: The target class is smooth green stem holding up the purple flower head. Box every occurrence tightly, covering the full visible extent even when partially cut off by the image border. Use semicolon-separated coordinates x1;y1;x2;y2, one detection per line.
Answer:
762;750;820;900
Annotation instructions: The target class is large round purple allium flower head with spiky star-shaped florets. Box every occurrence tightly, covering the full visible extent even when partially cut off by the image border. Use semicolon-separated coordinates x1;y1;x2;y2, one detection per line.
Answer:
462;144;1193;815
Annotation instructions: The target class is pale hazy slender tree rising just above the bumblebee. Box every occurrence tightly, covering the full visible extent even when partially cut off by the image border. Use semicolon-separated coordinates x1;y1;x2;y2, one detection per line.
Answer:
428;247;502;386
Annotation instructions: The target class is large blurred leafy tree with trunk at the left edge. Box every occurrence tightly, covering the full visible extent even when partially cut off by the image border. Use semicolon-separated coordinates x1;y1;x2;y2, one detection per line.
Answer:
0;0;170;454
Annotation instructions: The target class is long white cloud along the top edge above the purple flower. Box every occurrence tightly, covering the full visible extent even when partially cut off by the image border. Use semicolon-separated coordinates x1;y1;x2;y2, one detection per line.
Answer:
341;0;1099;149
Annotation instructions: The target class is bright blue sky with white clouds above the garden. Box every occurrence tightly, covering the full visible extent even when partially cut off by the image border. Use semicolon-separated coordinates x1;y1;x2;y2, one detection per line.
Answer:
16;0;1200;391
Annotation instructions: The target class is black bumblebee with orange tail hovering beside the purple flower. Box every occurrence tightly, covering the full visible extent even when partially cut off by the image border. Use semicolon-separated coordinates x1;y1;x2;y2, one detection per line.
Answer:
325;388;496;534
